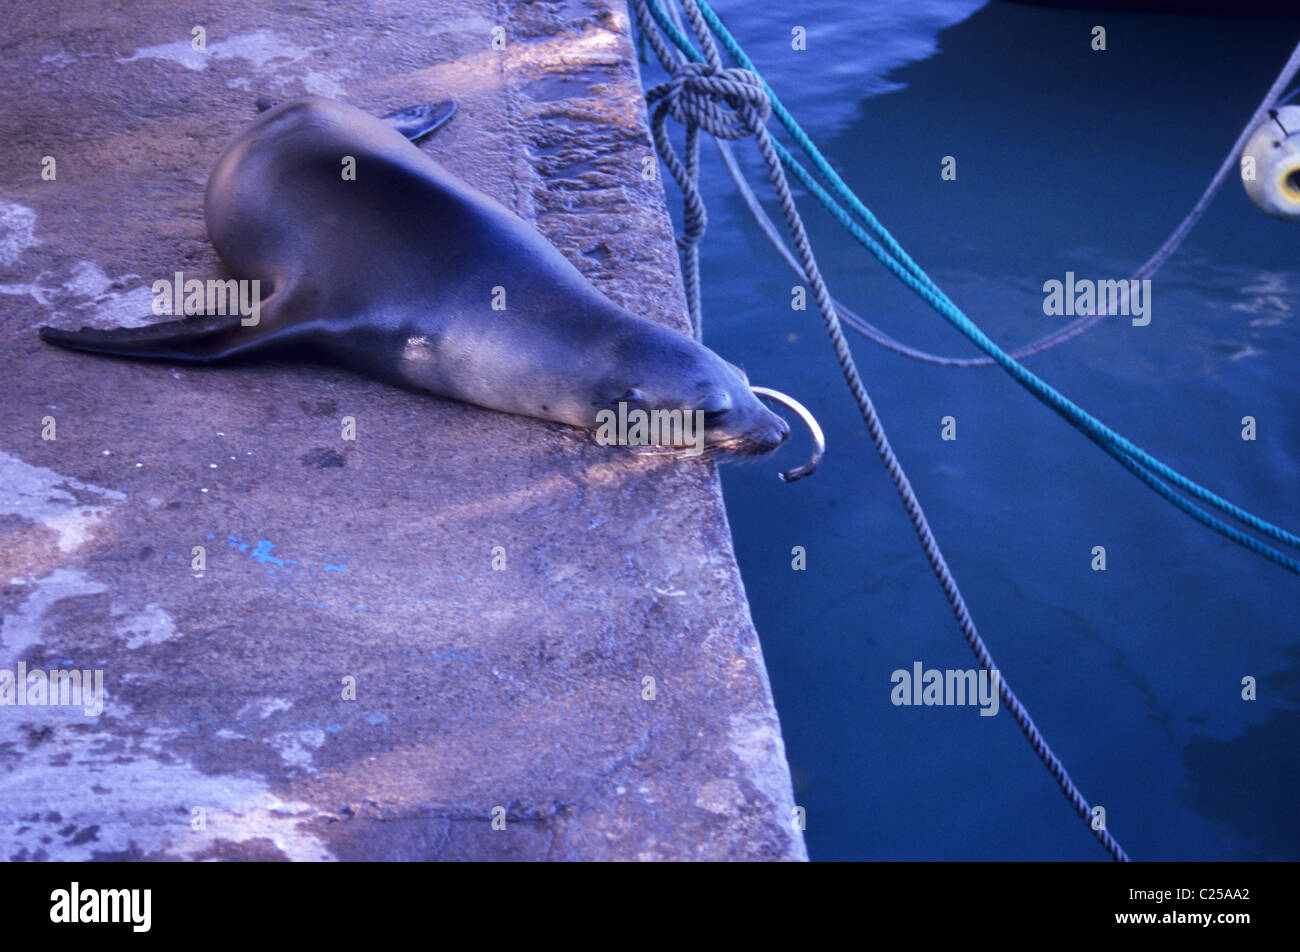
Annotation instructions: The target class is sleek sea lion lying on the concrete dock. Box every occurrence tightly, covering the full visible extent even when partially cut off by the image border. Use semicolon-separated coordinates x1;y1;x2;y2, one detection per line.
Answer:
40;96;789;455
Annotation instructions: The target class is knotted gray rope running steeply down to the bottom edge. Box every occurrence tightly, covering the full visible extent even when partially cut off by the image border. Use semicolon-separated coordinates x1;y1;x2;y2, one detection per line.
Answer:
631;0;1128;861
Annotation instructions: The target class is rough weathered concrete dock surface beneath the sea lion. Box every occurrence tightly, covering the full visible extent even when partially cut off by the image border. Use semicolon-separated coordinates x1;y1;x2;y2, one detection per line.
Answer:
0;0;805;860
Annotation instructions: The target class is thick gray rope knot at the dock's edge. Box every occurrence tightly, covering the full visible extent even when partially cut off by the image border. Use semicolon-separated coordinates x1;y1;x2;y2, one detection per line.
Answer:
646;62;772;140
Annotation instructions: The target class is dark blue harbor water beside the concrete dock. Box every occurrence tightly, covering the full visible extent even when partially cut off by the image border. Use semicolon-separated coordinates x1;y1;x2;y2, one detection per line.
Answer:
644;0;1300;860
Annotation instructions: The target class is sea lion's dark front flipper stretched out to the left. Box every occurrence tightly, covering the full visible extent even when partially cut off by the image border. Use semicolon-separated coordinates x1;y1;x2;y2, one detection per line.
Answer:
39;304;286;363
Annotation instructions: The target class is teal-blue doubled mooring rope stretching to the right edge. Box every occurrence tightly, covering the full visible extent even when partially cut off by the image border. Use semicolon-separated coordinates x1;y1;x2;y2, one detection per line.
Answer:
646;0;1300;575
